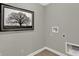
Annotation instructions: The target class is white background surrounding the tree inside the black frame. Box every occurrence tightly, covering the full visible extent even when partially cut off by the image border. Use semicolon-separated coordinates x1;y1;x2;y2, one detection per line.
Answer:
4;8;32;26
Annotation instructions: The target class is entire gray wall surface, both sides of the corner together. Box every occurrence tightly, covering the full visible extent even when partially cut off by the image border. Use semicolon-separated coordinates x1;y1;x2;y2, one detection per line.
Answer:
0;3;79;56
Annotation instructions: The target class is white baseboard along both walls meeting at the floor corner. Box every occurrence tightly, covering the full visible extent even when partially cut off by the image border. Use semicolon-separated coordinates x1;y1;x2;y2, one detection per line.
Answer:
27;47;67;56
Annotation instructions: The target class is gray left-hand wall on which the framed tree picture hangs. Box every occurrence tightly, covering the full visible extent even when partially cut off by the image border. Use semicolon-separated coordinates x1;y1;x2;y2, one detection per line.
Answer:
0;3;45;56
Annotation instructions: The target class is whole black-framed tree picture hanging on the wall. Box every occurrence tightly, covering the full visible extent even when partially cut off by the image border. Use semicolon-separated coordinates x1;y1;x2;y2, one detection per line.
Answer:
0;3;34;31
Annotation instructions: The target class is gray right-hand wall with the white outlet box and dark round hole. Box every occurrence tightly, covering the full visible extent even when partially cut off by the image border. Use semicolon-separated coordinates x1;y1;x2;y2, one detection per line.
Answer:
45;3;79;53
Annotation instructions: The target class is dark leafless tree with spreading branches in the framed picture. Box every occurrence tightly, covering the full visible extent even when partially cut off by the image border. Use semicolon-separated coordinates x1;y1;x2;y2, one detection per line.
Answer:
7;12;30;27
